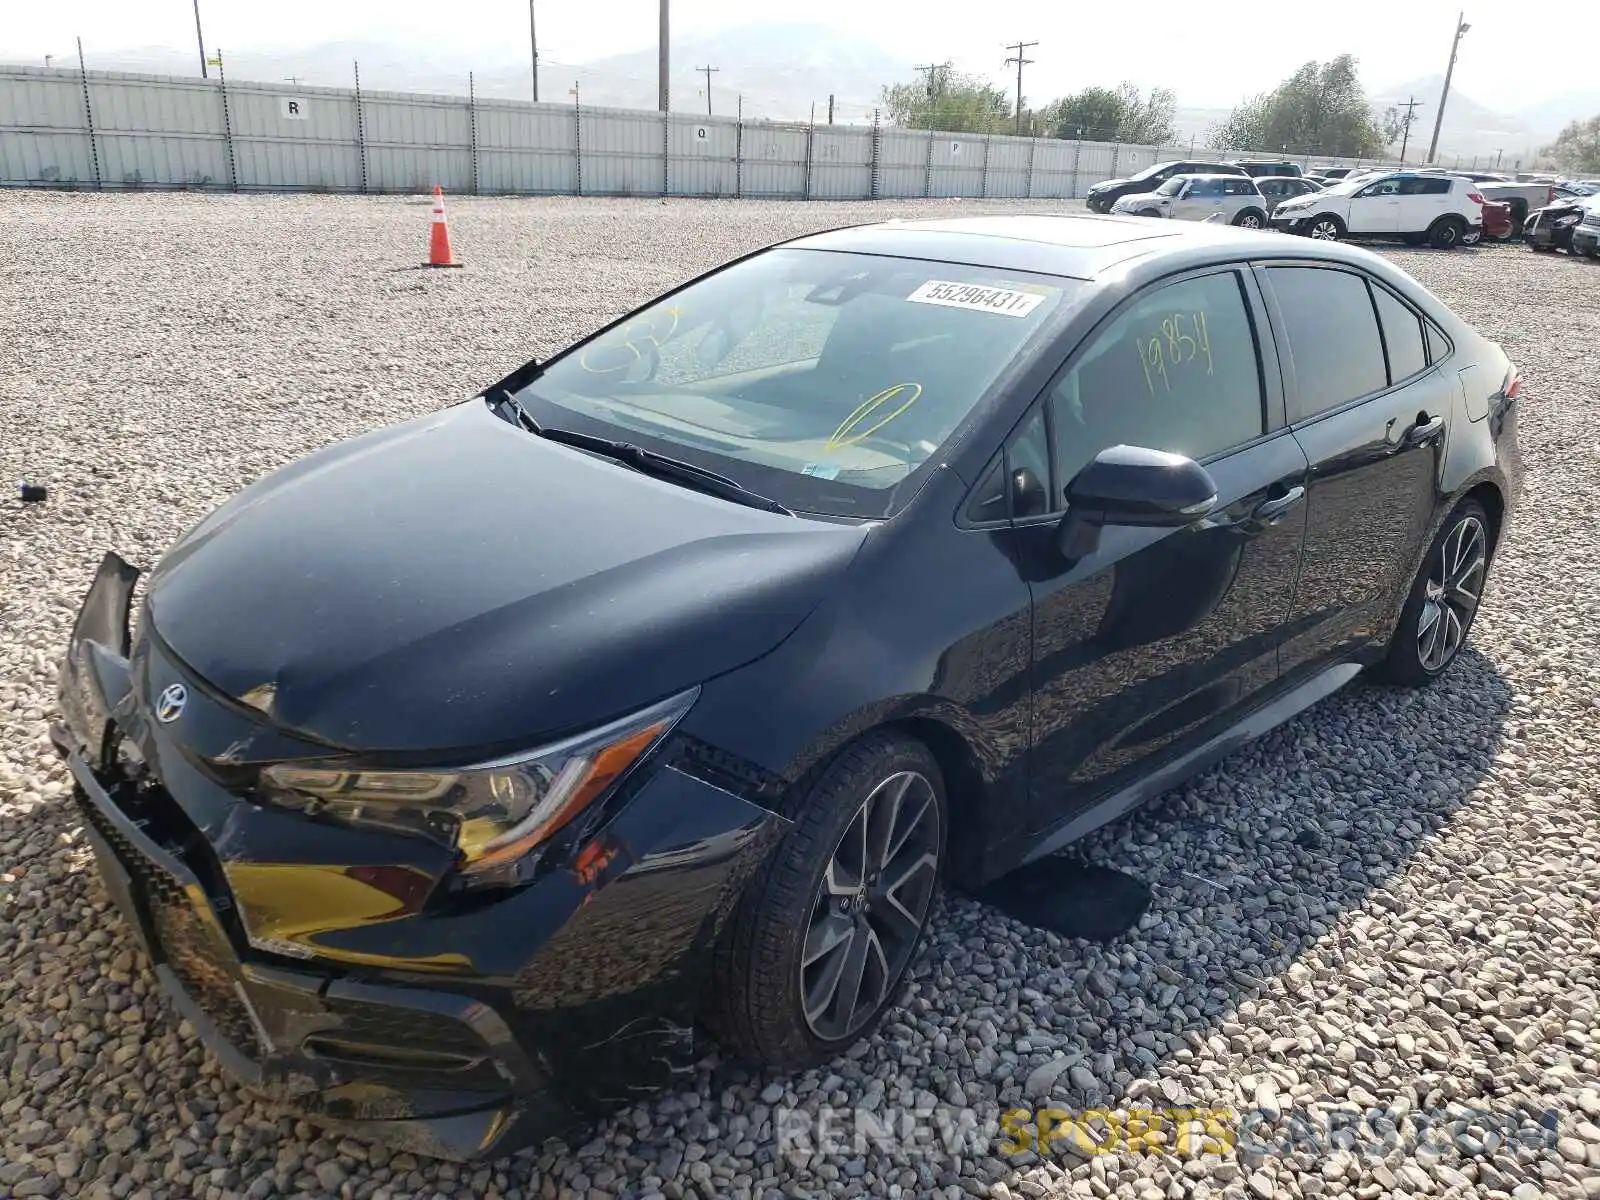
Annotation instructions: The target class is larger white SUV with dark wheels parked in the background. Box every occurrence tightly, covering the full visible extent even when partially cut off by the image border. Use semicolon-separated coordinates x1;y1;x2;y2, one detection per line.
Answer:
1272;171;1483;250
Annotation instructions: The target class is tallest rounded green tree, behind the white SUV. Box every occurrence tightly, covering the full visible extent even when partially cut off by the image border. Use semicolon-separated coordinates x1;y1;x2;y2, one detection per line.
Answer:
1210;54;1400;157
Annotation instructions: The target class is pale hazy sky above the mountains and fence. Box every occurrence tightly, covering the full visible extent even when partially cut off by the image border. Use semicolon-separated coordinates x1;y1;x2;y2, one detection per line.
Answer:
0;0;1574;107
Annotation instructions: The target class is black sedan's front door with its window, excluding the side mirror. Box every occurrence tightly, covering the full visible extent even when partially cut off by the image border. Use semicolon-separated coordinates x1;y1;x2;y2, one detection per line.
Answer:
1018;269;1306;830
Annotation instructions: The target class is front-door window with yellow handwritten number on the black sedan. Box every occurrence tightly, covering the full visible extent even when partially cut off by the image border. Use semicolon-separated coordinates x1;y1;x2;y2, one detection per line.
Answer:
1050;270;1266;498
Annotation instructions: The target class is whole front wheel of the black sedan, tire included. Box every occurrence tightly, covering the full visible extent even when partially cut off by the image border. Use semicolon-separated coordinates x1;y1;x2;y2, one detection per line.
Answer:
707;733;949;1070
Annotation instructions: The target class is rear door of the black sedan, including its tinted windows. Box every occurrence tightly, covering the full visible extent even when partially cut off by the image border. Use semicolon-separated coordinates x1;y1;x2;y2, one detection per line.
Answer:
1256;262;1454;682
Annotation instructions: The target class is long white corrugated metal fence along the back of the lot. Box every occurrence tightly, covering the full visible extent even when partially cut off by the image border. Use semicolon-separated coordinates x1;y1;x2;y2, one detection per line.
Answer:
0;66;1401;200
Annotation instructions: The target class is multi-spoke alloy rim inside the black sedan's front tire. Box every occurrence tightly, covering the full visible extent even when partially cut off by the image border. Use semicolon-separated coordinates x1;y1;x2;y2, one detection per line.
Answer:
800;771;941;1042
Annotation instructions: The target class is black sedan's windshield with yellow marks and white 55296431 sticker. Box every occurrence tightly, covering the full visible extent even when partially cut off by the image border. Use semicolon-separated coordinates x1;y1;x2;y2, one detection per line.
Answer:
517;248;1086;517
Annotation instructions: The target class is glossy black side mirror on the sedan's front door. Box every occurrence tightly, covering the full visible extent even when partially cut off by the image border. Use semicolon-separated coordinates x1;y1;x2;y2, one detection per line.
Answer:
1059;446;1216;558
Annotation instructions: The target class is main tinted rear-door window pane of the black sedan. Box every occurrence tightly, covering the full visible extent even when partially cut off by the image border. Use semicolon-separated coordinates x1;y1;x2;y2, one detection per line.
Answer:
1267;267;1389;421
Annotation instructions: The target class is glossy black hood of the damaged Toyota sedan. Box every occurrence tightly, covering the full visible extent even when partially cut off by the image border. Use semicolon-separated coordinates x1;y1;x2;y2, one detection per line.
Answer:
147;402;866;752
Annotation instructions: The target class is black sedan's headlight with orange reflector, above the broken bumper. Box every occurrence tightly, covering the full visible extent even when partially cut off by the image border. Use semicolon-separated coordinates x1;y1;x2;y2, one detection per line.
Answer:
261;688;699;885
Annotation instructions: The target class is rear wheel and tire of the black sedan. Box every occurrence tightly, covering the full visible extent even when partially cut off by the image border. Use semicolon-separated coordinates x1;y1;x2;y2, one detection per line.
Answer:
1376;501;1494;688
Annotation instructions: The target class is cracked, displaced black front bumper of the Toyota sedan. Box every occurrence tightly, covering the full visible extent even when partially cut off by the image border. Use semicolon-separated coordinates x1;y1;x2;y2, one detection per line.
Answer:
51;555;786;1158
